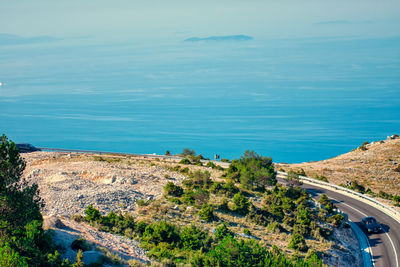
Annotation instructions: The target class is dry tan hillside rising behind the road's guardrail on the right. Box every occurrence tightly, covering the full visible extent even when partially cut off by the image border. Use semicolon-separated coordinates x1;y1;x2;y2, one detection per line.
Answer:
277;136;400;197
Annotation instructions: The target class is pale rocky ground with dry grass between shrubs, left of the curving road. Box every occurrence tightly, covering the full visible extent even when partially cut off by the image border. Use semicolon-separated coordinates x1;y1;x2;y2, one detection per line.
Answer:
23;152;361;266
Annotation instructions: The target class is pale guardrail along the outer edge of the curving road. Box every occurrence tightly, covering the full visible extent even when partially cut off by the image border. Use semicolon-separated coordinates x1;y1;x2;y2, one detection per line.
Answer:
278;171;400;223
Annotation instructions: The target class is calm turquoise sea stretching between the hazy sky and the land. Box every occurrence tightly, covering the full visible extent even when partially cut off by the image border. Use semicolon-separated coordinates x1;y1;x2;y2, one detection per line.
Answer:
0;38;400;162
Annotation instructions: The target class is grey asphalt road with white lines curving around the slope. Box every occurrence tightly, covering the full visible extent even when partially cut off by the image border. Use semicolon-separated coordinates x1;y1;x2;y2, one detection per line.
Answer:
278;179;400;267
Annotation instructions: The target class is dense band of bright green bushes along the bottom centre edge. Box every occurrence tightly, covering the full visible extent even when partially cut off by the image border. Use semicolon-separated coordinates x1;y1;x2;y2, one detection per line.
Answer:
86;209;322;266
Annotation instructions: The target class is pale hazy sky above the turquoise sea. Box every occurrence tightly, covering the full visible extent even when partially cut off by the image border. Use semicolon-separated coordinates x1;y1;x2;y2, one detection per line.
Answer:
0;0;400;40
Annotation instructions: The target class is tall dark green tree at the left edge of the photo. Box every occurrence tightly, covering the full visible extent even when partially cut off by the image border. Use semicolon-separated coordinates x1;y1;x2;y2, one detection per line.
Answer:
0;134;70;267
